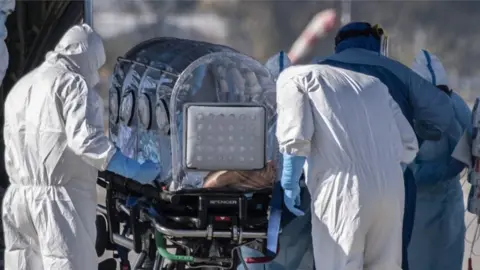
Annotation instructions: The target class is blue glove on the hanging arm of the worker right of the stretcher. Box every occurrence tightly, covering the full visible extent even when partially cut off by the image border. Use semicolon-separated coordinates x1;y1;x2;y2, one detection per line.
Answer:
281;154;306;216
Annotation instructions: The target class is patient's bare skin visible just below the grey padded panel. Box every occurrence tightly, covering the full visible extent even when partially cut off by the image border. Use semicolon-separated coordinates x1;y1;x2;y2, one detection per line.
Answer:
203;161;277;190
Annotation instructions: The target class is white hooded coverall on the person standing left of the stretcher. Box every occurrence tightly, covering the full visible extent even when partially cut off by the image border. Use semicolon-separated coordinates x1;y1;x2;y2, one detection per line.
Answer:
2;25;116;270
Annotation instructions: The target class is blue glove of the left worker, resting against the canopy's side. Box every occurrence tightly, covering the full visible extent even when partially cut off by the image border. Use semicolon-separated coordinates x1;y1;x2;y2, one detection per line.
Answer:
107;150;160;184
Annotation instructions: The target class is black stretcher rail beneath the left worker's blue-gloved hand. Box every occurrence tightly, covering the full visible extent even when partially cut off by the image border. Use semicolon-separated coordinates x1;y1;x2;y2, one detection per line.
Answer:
97;171;177;203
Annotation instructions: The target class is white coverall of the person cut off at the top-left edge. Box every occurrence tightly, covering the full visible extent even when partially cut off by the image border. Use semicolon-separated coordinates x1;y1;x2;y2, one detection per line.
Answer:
0;0;15;85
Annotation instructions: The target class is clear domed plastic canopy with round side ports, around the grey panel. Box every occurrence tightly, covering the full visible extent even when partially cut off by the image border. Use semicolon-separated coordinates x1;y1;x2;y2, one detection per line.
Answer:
109;38;278;190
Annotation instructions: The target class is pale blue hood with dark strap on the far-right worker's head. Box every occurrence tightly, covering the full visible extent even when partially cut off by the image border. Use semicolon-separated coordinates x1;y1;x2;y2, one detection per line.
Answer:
412;50;448;86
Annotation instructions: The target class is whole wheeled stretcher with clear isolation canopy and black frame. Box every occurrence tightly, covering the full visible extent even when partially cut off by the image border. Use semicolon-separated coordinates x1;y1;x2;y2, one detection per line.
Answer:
97;38;283;270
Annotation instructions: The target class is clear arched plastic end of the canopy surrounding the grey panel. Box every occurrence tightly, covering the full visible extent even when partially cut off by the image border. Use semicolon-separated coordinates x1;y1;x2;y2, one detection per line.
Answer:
170;52;278;190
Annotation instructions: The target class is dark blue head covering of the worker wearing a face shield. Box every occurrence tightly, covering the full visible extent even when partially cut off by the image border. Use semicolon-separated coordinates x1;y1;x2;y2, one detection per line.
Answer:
335;22;381;53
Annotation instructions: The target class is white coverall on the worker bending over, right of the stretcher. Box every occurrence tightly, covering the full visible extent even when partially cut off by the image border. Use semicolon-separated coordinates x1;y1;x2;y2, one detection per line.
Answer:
277;65;418;270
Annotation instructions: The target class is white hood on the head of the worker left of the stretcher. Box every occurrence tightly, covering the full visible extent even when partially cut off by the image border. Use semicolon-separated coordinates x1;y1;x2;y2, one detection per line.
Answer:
46;24;106;87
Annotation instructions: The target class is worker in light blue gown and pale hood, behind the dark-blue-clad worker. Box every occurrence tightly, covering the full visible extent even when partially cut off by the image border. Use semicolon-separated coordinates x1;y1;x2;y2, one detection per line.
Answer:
408;50;472;270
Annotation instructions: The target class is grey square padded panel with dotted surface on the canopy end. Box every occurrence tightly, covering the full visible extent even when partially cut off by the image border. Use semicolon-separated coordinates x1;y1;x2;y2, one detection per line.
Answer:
183;103;266;171
